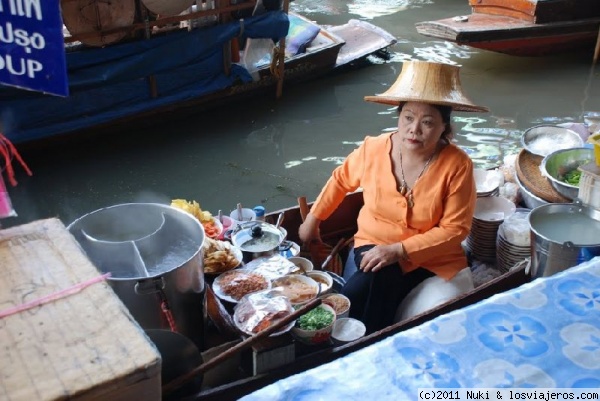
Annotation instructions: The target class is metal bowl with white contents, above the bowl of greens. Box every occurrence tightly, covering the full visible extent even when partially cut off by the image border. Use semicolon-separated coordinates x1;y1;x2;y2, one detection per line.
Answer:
521;125;584;157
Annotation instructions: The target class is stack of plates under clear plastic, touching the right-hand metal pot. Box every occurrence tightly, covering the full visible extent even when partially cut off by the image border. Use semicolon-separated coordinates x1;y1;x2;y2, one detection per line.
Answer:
496;209;531;272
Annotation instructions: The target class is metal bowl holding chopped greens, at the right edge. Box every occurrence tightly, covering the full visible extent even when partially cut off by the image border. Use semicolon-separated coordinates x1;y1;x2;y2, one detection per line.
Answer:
540;148;594;200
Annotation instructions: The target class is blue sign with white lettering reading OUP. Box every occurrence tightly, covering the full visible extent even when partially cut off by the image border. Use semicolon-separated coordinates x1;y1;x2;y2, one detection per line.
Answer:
0;0;69;96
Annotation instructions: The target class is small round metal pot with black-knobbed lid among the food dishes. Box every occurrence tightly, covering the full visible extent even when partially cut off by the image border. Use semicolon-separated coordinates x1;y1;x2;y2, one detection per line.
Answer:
231;221;285;263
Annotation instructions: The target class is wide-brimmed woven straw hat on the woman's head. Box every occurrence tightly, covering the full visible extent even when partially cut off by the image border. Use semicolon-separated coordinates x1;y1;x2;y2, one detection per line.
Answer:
365;60;489;111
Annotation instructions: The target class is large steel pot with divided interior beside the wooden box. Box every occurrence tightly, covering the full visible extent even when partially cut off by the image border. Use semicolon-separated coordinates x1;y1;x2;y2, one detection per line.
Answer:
68;203;205;349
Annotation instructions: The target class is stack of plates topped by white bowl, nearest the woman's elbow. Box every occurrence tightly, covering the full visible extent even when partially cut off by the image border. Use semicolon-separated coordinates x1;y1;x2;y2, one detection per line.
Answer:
466;196;516;263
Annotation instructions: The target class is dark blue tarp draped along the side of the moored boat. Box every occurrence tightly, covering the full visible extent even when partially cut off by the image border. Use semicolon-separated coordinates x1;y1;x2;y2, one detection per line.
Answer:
0;11;289;143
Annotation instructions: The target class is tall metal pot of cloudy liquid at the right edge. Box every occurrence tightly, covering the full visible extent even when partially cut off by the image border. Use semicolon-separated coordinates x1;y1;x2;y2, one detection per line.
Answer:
529;202;600;277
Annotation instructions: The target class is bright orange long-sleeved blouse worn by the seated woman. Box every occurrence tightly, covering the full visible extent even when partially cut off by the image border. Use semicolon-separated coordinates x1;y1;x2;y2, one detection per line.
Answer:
311;133;477;280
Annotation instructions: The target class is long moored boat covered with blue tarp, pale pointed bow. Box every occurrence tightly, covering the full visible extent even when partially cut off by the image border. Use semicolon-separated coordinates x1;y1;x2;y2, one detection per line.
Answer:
0;5;395;144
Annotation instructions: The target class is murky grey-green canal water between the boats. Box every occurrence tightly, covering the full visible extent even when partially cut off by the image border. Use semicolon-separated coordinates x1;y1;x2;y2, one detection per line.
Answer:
0;0;600;227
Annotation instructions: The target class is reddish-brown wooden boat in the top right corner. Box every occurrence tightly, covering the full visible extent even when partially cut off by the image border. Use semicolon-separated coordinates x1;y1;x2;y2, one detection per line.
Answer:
415;0;600;56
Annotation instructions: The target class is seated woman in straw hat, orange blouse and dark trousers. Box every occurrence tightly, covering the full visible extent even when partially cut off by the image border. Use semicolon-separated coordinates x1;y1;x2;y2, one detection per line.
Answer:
299;61;487;333
